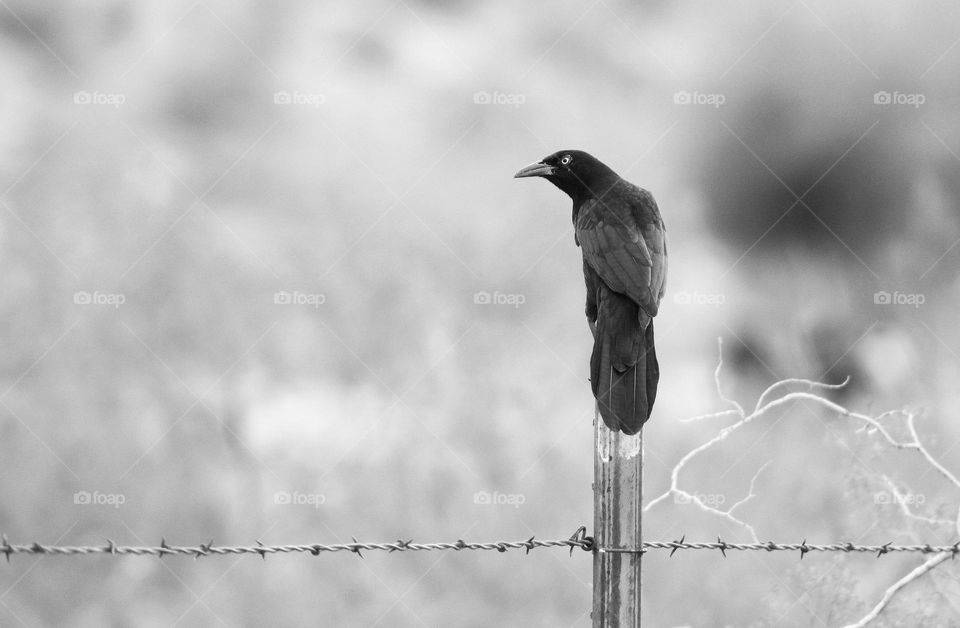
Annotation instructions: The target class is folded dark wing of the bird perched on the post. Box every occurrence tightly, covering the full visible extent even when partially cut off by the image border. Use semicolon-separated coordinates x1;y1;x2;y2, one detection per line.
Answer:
576;184;667;316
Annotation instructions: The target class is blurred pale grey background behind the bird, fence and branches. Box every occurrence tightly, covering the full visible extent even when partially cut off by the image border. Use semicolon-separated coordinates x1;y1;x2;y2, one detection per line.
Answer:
0;0;960;627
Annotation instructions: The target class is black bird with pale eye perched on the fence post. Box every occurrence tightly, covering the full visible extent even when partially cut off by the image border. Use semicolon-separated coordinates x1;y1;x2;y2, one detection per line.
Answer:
513;150;667;434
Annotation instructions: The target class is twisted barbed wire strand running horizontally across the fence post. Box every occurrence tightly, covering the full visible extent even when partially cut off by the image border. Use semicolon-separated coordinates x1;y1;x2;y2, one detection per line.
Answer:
0;526;960;562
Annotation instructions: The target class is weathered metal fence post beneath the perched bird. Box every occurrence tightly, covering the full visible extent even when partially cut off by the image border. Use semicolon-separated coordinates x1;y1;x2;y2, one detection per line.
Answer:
591;414;643;628
